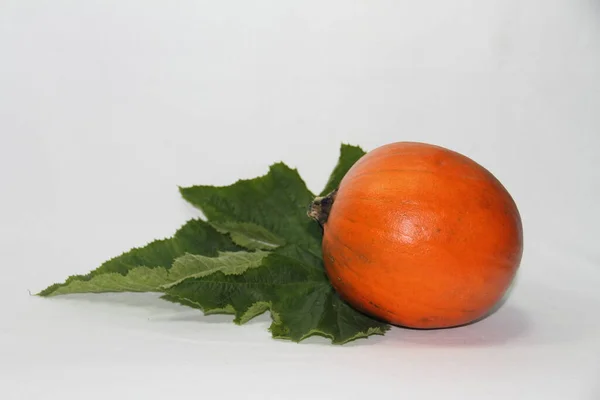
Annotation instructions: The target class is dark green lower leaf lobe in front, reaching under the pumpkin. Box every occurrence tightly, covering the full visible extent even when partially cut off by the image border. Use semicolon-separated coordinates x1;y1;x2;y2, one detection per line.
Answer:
165;245;389;343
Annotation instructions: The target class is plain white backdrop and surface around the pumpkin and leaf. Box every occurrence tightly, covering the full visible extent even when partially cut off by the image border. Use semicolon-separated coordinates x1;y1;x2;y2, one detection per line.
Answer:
0;0;600;400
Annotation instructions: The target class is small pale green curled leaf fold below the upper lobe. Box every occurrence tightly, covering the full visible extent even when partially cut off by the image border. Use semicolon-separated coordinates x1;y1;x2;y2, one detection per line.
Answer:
211;222;285;250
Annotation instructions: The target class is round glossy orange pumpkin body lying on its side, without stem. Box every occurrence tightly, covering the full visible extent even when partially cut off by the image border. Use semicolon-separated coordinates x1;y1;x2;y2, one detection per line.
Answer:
323;142;523;328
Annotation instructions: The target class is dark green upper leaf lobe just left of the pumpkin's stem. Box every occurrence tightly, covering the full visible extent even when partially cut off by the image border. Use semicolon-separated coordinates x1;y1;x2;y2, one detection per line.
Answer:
180;163;321;255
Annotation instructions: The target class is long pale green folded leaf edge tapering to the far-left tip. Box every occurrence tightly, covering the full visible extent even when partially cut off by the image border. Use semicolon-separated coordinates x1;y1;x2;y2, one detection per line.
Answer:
39;251;268;296
